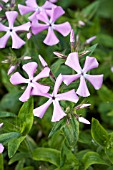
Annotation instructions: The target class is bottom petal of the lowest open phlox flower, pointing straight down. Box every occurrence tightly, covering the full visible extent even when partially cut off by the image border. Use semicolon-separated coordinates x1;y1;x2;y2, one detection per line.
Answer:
51;100;66;122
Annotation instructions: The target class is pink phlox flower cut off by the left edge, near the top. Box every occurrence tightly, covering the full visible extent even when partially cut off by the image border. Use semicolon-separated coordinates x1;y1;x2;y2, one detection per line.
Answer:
0;11;31;49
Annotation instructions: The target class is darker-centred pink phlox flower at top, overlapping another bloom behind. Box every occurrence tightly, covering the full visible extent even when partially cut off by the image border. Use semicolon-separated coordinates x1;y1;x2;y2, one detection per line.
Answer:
31;6;71;46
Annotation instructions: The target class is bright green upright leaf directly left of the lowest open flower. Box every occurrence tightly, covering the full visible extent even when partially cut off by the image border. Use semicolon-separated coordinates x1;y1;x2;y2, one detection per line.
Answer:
18;98;34;135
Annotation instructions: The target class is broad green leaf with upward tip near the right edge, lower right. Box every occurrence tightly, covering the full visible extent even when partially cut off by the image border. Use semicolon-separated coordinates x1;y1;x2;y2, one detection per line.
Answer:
91;118;109;146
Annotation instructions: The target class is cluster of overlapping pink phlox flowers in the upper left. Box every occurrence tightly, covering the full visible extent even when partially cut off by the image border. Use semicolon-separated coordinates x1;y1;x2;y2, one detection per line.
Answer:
0;0;71;49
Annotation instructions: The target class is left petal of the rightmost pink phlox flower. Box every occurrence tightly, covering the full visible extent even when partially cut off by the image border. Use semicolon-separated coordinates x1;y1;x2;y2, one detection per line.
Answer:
62;74;80;86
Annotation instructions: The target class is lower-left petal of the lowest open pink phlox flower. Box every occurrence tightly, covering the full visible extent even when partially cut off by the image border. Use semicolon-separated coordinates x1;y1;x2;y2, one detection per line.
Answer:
33;99;52;118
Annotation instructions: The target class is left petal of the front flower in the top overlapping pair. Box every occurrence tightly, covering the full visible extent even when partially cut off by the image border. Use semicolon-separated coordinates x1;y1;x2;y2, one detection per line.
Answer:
31;23;49;35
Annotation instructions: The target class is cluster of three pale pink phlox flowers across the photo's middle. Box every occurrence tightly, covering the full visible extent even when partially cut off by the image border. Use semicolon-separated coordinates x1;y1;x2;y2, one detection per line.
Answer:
10;52;103;123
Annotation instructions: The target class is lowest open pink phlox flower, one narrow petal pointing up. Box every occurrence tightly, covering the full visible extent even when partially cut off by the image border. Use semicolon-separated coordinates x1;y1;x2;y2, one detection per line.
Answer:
32;74;78;122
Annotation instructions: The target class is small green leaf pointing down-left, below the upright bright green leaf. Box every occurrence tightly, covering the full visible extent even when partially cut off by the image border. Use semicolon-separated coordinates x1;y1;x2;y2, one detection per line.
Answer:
8;136;25;158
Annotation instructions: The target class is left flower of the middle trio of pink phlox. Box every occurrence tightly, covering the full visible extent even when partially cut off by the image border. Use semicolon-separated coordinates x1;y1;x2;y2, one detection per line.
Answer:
10;62;50;102
